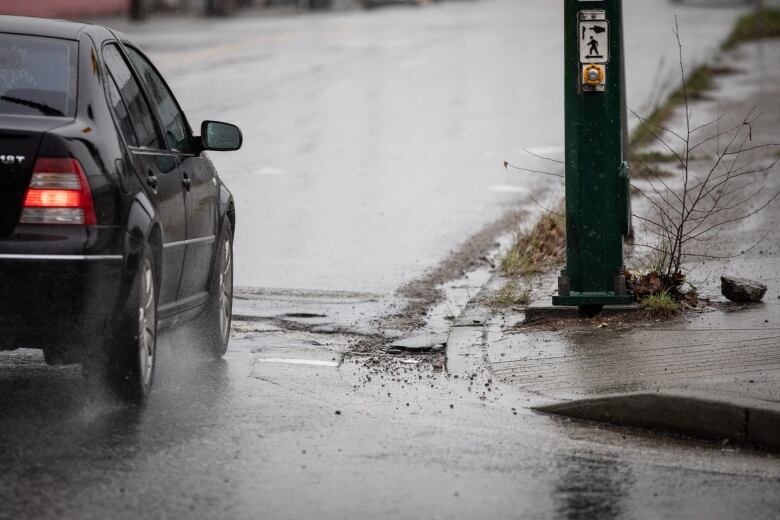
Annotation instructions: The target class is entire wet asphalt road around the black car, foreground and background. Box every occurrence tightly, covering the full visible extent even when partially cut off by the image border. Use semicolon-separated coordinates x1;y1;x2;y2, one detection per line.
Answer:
0;0;780;519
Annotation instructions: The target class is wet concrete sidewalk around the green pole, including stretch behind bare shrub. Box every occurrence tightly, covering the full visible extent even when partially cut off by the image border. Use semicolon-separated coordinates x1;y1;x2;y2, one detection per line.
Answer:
447;40;780;449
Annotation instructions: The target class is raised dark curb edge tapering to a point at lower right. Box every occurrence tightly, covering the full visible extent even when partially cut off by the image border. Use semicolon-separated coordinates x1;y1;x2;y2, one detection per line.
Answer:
533;391;780;450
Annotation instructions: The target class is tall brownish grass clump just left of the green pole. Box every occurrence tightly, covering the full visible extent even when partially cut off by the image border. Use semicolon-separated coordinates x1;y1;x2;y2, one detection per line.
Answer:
501;212;566;277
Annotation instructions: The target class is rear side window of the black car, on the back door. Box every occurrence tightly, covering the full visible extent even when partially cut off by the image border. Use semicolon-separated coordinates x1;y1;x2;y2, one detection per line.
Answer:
103;44;162;149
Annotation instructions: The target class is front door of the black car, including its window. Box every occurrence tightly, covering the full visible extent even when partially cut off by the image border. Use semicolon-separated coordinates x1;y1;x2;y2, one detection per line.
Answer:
125;44;217;303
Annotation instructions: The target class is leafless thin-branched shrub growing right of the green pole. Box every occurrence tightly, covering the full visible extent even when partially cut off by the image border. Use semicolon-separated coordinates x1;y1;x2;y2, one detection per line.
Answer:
634;17;780;283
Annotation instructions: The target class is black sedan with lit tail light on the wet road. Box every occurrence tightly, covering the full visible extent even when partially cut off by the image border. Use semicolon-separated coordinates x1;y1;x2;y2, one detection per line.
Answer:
0;16;242;402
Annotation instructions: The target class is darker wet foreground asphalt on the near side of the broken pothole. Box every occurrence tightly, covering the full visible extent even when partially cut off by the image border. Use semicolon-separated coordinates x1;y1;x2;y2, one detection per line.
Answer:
0;323;780;518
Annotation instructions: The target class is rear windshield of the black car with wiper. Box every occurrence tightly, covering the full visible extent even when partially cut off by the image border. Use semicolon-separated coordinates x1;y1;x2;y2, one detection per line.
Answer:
0;33;78;117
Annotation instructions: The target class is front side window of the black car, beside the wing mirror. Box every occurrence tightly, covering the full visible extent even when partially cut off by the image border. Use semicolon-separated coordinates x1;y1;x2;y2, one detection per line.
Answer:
126;47;191;153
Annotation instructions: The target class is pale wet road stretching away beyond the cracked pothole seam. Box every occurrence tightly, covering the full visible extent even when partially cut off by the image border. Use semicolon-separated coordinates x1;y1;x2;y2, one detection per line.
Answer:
117;0;740;292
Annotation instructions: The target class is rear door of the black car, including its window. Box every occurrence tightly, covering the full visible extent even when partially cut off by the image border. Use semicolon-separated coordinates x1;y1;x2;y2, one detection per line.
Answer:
102;43;187;306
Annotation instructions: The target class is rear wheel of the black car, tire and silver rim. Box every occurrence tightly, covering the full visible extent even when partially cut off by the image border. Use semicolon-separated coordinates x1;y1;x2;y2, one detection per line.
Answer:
85;246;157;405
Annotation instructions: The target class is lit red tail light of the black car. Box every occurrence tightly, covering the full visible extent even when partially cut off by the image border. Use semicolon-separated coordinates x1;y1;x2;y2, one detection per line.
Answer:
19;157;97;226
